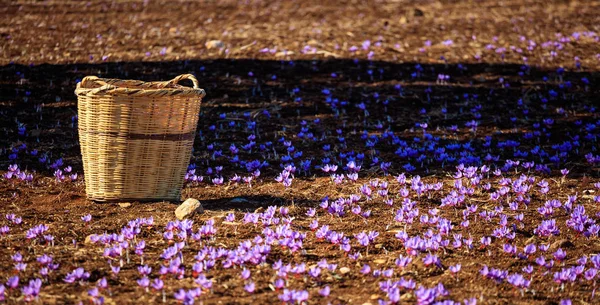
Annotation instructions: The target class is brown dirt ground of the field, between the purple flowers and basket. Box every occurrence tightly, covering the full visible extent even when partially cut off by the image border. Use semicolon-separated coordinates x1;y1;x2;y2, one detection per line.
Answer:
0;0;600;304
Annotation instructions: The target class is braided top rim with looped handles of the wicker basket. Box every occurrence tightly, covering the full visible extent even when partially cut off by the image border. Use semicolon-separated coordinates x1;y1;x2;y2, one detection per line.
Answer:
75;74;206;99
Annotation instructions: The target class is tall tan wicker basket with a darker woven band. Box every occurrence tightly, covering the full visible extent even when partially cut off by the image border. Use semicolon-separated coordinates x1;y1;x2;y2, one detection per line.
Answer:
75;74;205;201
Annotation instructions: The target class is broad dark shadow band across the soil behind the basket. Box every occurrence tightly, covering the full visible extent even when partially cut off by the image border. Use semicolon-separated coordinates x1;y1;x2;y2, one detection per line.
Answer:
0;59;600;175
